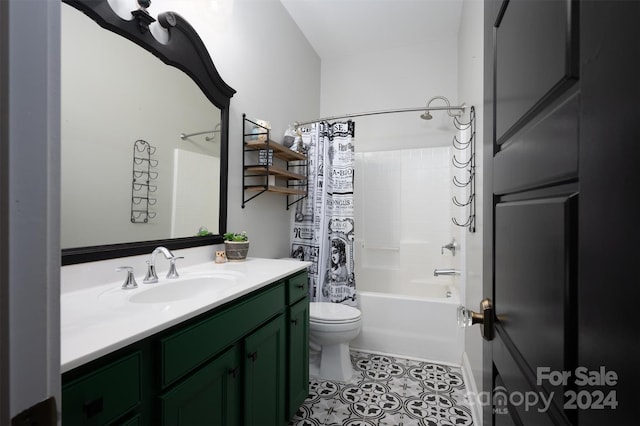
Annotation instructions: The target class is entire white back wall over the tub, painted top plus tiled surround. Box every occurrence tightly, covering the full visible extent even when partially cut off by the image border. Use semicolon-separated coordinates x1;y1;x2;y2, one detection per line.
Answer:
320;37;460;294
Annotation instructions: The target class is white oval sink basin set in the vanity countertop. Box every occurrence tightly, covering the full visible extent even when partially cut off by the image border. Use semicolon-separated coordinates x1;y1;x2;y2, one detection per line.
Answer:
98;271;243;308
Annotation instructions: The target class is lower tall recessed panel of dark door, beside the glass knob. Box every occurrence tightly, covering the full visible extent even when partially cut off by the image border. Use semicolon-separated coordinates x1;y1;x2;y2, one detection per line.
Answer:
494;197;572;386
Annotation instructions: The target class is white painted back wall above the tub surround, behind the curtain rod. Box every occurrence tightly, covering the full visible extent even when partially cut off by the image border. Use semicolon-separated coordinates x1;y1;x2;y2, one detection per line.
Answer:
320;37;458;152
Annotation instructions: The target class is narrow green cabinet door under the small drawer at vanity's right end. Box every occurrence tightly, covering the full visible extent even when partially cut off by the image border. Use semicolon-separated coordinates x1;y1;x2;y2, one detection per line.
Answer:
287;297;309;419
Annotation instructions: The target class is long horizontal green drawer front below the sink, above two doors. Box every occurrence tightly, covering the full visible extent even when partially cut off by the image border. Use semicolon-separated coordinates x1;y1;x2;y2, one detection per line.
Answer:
160;283;285;387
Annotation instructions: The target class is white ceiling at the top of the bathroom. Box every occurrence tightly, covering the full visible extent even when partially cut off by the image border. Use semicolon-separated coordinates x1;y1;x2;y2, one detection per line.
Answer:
280;0;463;59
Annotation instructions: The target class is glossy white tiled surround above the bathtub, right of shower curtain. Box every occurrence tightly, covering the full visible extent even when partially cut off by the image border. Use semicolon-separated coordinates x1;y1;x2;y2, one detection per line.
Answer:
355;146;459;300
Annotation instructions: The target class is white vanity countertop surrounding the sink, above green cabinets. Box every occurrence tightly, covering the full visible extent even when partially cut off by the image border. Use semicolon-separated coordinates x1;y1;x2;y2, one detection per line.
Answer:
60;258;309;373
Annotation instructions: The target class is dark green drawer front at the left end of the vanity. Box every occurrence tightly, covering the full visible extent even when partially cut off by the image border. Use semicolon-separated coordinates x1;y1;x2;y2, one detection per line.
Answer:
62;352;141;425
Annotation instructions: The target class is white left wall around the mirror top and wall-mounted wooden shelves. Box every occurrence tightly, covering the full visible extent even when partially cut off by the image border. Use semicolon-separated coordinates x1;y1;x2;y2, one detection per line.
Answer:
149;0;320;257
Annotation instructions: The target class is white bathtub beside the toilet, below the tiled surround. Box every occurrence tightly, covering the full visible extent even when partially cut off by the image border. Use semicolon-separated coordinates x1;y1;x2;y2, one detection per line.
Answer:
350;281;464;365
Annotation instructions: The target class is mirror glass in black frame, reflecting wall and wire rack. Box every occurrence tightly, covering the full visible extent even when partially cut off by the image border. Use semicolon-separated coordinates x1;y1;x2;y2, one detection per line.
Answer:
61;4;221;249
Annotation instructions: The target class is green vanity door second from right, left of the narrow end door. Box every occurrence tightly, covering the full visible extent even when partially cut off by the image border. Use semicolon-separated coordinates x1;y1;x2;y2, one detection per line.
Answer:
244;315;286;426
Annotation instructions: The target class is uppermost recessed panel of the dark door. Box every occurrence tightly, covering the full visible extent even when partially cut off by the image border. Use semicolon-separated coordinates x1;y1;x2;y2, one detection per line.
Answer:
495;0;577;143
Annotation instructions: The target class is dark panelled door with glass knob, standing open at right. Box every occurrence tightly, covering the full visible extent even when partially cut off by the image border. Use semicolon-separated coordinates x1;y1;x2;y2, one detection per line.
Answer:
483;0;640;425
